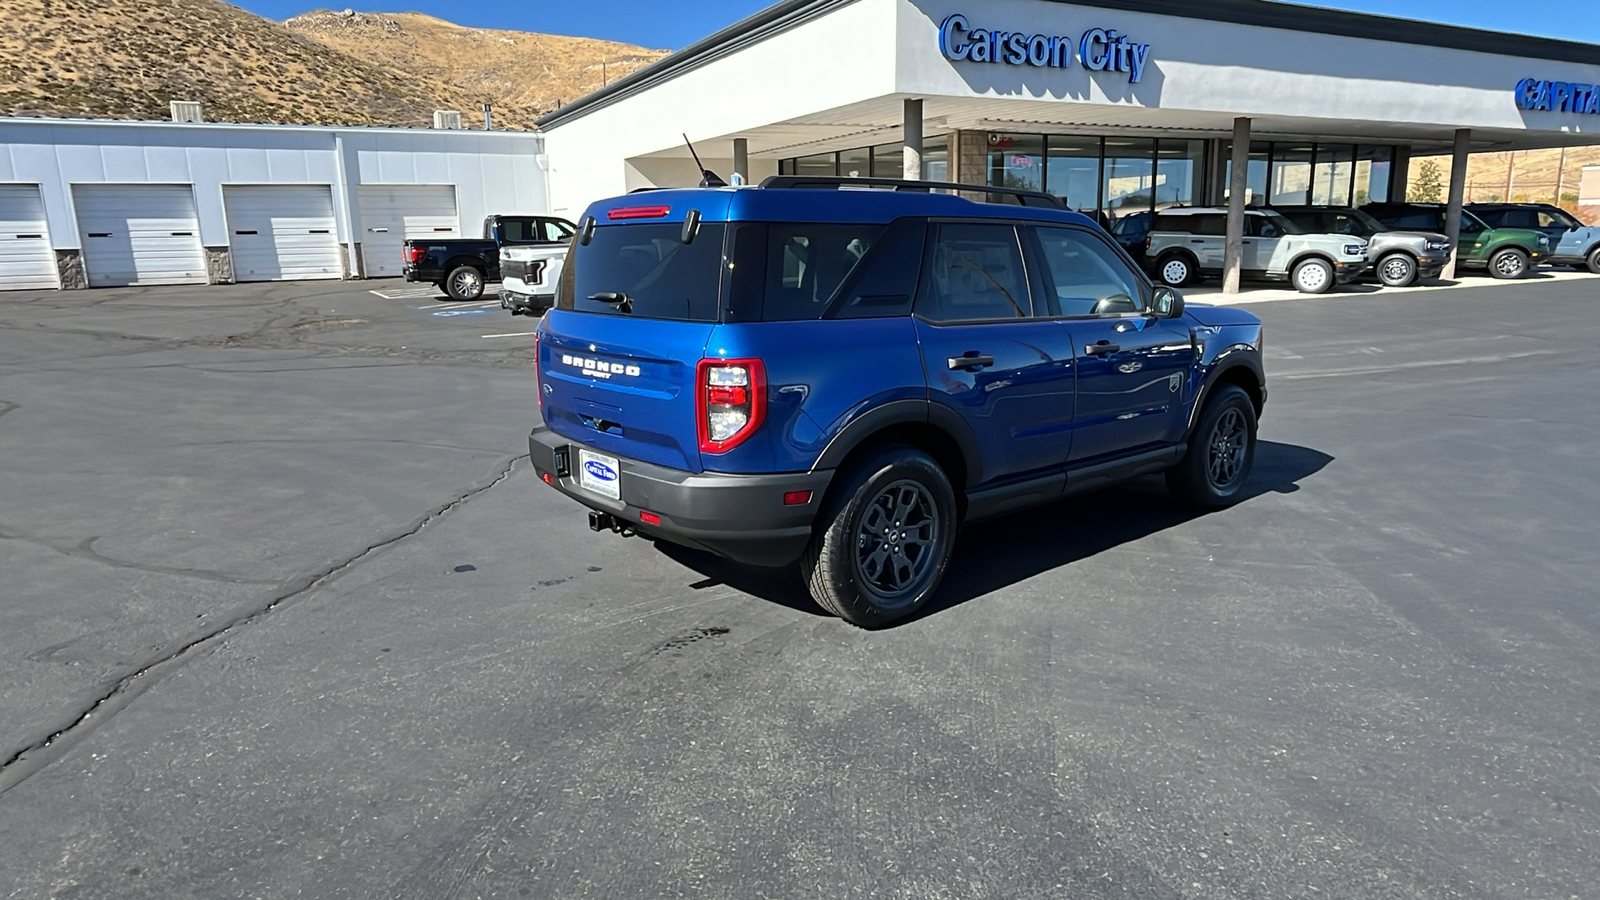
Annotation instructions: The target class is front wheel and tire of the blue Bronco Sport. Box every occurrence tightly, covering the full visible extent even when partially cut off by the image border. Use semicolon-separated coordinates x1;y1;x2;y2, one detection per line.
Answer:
1166;384;1256;509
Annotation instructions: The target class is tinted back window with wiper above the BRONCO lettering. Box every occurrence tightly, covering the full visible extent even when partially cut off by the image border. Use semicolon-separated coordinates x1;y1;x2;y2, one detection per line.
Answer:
555;223;726;322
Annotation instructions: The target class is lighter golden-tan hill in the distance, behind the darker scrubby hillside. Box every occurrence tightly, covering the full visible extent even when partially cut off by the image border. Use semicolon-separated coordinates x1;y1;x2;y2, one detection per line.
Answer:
283;10;666;122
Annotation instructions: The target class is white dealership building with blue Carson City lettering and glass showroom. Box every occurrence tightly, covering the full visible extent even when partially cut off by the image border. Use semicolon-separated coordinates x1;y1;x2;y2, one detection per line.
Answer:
539;0;1600;285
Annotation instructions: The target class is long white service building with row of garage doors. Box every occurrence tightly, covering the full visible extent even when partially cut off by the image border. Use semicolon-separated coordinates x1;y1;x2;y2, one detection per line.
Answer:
0;119;549;290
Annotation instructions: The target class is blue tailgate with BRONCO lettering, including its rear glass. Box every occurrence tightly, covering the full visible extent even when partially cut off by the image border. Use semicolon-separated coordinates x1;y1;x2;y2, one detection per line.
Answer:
539;221;726;472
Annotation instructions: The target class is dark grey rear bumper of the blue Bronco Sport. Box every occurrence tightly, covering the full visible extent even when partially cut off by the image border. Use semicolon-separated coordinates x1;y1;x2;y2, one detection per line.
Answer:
528;424;834;567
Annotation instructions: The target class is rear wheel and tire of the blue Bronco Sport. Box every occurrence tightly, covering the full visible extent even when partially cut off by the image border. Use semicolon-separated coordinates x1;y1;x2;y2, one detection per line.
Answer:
800;444;957;628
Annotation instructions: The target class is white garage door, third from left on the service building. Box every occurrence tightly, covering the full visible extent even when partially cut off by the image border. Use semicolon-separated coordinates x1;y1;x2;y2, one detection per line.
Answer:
222;184;344;282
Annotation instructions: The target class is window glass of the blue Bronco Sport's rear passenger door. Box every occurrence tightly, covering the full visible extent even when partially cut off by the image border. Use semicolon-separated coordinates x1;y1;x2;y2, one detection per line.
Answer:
917;223;1032;322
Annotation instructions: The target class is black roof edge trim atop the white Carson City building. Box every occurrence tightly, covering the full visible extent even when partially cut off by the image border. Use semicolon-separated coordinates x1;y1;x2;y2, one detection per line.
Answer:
538;0;1600;128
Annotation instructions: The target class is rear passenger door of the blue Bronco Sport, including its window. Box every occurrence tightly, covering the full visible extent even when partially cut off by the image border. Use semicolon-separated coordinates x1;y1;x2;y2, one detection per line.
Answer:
915;221;1074;487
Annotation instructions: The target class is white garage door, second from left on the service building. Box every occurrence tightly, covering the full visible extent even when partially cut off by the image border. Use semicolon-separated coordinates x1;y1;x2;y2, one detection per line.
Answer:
72;184;206;287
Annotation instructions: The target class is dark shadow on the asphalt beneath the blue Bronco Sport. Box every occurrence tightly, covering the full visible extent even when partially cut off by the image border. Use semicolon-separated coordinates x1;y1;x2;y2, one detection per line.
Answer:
656;440;1333;628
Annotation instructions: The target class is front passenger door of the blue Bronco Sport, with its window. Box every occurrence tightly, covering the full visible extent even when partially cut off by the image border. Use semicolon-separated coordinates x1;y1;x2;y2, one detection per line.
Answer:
1029;226;1195;463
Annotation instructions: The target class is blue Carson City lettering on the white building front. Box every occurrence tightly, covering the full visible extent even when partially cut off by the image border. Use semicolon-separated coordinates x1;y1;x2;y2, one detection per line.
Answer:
939;13;1150;85
